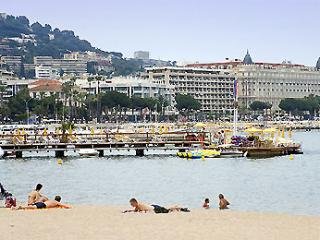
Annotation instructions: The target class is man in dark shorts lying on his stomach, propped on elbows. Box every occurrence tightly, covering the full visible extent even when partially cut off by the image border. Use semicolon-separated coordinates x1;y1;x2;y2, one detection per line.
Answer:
123;198;190;213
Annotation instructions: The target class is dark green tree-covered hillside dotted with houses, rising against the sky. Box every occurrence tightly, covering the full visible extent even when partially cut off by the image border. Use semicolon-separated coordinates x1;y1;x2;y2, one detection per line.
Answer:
0;15;122;63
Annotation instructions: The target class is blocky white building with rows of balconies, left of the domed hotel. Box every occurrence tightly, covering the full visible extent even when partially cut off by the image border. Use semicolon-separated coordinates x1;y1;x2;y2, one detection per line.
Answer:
143;67;235;113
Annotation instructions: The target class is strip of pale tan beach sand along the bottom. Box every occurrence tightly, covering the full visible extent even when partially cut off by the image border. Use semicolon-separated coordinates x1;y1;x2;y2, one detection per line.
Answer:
0;206;320;240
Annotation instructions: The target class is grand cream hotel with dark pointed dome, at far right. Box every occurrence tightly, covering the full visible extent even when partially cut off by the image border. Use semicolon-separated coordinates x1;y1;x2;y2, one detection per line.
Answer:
188;52;320;110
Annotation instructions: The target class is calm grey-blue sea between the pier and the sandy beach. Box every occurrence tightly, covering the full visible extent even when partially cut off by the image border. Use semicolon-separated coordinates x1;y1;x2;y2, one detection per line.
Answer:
0;131;320;215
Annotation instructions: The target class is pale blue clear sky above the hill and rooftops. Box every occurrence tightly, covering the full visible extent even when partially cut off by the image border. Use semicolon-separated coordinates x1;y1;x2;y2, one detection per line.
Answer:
0;0;320;66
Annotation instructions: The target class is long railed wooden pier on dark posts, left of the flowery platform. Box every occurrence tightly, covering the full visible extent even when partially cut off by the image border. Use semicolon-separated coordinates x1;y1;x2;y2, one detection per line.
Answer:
0;132;211;158
